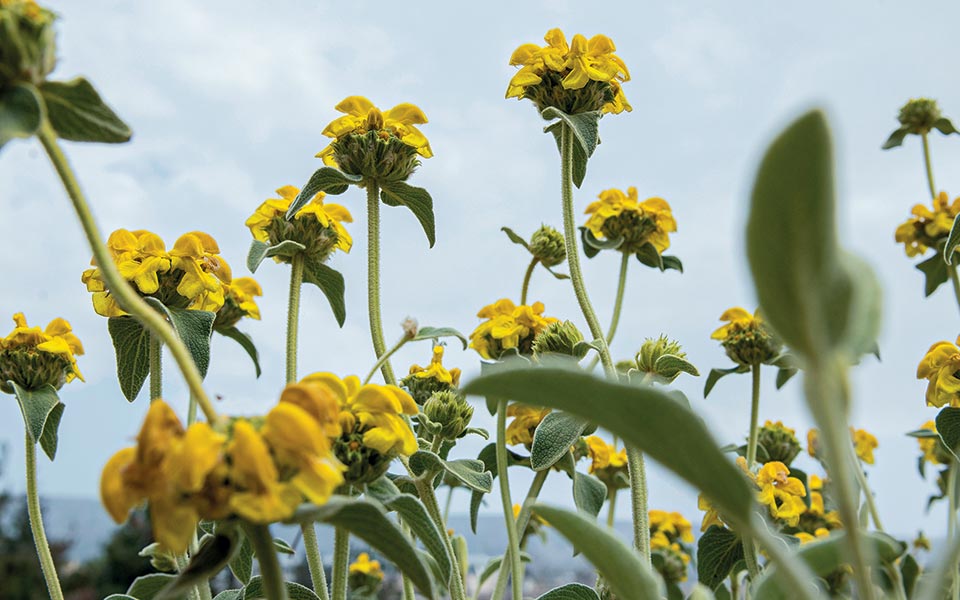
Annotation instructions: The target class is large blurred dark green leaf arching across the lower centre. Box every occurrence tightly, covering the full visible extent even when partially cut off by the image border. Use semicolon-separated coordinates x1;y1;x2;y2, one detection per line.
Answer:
464;368;753;526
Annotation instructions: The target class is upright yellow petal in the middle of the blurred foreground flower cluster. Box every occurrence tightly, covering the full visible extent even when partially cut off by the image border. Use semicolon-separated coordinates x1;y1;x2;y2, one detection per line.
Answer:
227;420;302;523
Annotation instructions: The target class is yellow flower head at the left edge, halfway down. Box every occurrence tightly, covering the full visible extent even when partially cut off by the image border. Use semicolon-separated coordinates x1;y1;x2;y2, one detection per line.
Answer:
0;313;83;393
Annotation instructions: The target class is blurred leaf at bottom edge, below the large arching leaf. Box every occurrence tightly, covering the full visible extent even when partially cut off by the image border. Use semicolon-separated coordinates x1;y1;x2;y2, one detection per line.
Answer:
533;504;662;600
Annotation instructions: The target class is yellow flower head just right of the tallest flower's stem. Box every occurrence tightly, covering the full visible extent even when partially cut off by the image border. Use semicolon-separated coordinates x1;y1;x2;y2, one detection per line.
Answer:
584;186;677;254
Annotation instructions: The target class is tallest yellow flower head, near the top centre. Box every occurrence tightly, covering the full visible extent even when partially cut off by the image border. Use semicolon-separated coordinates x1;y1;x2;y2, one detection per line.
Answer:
506;29;632;114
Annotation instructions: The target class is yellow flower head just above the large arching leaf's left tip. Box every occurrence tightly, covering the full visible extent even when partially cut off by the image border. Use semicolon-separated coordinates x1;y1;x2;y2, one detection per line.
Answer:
470;298;559;360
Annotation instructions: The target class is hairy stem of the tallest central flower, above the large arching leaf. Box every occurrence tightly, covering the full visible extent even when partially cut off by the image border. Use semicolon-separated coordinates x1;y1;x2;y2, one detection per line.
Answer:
560;125;616;380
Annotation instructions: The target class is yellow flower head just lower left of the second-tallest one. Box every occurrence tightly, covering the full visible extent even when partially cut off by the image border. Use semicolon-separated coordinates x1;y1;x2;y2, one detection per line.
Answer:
245;185;353;262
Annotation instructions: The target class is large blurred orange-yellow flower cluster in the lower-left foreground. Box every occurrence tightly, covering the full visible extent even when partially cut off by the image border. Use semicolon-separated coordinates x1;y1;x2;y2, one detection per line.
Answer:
100;384;343;552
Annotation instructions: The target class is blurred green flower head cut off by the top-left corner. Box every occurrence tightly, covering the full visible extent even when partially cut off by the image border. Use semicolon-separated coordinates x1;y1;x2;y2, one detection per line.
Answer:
0;0;57;89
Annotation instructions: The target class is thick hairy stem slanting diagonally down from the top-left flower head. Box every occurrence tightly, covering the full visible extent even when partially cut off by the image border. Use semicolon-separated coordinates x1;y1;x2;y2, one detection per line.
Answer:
37;121;219;423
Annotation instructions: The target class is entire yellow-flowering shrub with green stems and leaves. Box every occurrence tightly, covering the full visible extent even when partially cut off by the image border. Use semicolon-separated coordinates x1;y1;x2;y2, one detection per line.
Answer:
0;5;960;600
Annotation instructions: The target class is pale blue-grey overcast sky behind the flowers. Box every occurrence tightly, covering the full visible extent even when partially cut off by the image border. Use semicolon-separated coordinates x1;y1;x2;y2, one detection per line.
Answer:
0;0;960;535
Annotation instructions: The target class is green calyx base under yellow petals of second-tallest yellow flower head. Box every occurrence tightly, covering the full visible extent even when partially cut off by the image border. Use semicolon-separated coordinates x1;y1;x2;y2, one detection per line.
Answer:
331;130;420;182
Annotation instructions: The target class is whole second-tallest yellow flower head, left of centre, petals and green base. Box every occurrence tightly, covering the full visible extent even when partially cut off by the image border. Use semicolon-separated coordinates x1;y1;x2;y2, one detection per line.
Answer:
317;96;433;181
